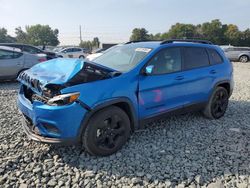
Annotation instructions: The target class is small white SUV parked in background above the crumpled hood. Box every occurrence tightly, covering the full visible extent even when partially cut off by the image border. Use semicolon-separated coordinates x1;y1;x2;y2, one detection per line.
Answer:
57;47;89;59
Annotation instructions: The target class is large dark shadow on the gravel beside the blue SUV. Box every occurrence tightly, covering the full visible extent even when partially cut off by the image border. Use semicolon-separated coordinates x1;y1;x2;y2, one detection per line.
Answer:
47;100;250;186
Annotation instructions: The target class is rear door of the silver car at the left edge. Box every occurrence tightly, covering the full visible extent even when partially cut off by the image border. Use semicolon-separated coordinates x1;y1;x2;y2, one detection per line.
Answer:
0;49;24;78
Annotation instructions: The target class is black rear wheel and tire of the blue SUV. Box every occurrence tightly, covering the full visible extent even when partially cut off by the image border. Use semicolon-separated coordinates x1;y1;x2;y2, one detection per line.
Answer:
203;87;229;119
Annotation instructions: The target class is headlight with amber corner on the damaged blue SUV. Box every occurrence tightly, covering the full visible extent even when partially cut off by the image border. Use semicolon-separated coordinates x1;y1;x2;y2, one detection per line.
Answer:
47;92;80;106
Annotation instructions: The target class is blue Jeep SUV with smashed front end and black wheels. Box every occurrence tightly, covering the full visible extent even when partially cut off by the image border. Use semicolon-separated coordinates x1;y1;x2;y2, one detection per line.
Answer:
18;40;233;156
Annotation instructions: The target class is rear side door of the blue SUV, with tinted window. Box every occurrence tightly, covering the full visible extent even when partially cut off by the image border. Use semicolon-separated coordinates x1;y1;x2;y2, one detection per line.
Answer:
183;47;214;106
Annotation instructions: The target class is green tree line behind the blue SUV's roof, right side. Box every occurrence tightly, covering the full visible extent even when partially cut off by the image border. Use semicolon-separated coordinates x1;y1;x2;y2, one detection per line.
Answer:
130;19;250;46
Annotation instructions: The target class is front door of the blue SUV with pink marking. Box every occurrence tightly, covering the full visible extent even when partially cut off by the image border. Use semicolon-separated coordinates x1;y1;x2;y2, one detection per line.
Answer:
139;47;186;119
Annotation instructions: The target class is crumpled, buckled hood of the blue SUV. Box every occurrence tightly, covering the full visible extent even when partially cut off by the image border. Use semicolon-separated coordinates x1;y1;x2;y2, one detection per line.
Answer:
18;58;117;94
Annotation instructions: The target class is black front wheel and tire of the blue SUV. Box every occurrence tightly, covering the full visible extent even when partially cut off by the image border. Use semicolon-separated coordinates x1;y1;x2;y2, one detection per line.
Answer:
82;106;130;156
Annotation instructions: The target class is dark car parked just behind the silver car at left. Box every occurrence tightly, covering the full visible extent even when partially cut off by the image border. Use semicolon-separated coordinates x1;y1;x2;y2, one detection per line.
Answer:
0;43;57;60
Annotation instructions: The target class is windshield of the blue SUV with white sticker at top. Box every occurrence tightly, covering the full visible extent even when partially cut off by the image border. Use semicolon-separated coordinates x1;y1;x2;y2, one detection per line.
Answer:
94;45;151;72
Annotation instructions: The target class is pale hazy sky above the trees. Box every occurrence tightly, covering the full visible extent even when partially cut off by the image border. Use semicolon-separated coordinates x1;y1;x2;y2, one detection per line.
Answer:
0;0;250;44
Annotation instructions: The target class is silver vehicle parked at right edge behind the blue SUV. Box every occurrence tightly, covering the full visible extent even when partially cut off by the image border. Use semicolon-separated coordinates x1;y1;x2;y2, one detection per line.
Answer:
222;46;250;63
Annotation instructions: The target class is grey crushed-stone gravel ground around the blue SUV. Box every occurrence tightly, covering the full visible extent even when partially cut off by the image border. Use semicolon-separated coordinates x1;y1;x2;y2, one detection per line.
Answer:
0;63;250;188
